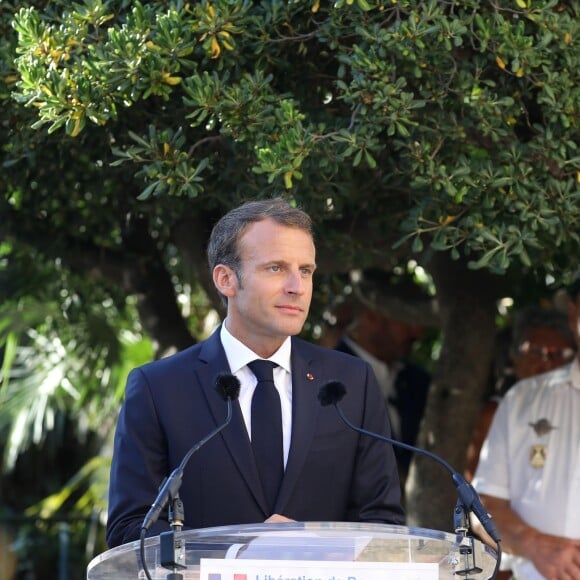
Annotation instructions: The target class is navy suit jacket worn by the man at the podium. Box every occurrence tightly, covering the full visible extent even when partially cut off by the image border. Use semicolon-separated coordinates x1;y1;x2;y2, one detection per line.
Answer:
107;330;404;547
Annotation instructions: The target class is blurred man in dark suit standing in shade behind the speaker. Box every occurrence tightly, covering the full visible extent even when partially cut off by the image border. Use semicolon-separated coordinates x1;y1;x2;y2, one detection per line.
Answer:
335;269;435;485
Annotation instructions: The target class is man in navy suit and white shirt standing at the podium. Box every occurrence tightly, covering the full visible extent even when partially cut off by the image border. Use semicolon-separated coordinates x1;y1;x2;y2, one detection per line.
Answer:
107;199;404;547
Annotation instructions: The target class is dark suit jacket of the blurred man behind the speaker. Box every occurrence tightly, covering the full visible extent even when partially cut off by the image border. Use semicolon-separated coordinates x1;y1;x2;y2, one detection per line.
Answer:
335;340;431;474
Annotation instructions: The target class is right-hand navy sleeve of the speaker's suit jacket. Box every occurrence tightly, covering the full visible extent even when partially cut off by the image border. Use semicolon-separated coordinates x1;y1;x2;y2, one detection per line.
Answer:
344;363;405;524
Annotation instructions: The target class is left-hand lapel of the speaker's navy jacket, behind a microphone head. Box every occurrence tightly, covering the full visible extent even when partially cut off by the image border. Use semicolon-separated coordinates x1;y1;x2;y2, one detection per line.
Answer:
196;329;267;512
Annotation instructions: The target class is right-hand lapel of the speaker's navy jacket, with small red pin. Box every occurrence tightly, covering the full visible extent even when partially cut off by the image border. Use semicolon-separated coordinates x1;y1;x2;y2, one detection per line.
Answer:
276;340;321;514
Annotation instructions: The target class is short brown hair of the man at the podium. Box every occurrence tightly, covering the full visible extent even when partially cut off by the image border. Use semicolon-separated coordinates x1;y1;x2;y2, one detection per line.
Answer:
207;197;313;301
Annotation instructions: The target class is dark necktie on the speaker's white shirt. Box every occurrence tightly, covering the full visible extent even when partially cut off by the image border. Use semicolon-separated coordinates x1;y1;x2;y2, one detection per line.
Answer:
248;360;284;510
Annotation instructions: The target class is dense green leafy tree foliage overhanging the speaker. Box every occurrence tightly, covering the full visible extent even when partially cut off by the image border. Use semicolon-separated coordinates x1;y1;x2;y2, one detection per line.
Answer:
7;0;580;271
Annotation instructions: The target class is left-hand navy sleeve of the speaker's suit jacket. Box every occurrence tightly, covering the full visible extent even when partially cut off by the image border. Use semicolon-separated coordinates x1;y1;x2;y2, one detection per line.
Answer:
107;369;169;548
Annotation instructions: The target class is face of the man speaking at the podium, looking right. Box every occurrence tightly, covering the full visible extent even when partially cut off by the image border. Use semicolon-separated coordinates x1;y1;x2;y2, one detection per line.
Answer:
214;218;316;357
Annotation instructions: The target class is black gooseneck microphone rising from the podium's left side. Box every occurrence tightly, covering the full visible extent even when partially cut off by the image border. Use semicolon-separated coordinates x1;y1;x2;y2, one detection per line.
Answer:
141;373;240;532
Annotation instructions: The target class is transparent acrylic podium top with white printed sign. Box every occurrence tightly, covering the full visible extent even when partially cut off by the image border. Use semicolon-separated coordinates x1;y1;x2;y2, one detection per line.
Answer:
87;522;496;580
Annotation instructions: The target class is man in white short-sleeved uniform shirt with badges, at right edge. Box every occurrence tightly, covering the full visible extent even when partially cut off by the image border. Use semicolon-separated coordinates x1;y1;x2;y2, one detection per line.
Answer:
473;277;580;580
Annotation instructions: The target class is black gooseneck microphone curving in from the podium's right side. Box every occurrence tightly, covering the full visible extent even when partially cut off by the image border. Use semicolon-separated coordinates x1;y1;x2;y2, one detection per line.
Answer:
318;381;501;547
